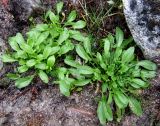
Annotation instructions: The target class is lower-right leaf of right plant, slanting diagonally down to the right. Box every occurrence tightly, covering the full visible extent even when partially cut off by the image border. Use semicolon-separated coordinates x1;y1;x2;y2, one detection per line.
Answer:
129;97;142;116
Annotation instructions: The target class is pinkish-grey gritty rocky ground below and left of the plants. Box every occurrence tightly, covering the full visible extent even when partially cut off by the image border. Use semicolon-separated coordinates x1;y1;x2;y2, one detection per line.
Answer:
0;0;160;126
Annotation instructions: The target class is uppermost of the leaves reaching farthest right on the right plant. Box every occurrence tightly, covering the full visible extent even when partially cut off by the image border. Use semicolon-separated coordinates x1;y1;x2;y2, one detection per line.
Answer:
137;60;157;70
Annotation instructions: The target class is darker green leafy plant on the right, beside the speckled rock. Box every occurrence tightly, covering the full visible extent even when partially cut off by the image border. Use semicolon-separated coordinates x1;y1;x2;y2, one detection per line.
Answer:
59;28;156;124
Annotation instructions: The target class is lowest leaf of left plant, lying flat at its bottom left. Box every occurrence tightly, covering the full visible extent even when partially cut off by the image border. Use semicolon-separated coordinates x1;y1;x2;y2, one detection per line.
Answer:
15;76;34;89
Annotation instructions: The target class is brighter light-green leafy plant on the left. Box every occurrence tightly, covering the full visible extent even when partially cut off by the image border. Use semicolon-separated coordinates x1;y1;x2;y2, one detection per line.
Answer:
2;2;87;88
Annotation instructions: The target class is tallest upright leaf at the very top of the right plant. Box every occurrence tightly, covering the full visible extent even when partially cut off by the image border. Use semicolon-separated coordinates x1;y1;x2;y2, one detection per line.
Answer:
116;27;124;47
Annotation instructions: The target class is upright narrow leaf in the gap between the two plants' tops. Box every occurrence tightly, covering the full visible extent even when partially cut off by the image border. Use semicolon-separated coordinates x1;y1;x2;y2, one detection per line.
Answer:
83;37;92;55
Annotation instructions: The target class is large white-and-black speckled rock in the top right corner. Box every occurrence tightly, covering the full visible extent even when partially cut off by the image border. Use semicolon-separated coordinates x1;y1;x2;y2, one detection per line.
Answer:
123;0;160;63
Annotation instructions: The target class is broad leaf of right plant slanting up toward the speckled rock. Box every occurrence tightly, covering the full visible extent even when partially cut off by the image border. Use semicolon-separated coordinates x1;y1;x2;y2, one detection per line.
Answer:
122;47;134;63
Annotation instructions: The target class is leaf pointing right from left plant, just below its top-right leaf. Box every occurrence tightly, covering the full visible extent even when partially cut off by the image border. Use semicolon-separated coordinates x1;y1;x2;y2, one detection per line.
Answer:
69;30;85;42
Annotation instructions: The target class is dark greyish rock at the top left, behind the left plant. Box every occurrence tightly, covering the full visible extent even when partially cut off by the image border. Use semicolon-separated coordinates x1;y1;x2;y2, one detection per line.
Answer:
11;0;43;21
